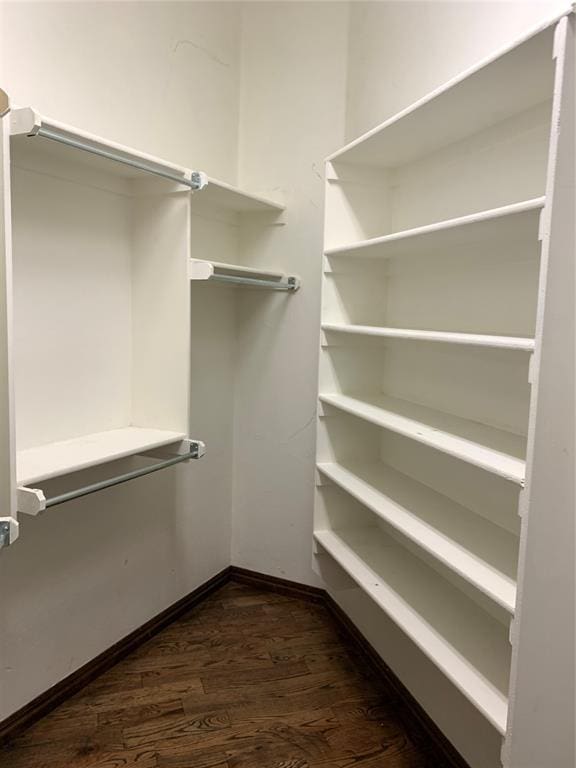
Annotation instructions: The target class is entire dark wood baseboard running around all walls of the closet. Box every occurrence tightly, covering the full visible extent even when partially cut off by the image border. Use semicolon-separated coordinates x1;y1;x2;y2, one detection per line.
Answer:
0;566;470;768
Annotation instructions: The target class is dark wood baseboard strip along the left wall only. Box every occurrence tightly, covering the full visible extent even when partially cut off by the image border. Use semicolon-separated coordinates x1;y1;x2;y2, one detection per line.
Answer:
0;567;230;745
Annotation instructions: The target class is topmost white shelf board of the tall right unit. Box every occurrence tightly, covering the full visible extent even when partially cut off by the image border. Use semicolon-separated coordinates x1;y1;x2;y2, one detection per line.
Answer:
328;19;564;168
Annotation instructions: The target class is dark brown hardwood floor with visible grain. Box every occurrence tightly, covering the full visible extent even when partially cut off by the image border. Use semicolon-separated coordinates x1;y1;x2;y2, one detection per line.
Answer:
0;583;442;768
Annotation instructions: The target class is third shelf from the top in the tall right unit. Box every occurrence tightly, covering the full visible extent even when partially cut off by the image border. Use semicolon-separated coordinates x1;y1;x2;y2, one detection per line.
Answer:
322;323;534;352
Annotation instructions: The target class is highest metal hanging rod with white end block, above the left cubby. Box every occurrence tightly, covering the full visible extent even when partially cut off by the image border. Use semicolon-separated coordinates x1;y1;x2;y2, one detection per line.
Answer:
11;107;208;191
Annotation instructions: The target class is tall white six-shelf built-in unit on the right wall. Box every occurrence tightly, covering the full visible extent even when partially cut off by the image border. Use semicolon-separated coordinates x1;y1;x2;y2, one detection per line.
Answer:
314;14;574;768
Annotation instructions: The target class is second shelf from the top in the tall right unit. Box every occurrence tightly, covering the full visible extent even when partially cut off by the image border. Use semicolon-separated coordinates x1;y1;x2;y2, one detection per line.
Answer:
325;197;546;259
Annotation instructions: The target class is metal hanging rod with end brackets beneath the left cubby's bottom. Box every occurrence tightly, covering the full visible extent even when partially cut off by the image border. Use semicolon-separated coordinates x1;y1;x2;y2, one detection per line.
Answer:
18;440;206;515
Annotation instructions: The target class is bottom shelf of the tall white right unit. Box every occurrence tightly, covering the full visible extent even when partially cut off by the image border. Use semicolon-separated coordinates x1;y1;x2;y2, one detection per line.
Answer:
314;528;510;734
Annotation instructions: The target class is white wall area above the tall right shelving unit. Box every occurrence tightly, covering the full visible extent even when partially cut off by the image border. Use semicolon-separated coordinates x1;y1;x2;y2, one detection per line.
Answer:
346;0;570;141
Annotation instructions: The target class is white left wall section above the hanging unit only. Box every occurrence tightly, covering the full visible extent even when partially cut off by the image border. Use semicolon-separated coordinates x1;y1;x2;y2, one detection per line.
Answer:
0;0;241;182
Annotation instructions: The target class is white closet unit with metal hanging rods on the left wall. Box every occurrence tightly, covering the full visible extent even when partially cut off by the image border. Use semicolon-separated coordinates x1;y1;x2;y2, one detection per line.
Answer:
0;108;299;520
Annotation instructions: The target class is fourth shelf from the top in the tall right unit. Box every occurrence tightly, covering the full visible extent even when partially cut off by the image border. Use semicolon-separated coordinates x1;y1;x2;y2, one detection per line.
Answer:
320;394;526;485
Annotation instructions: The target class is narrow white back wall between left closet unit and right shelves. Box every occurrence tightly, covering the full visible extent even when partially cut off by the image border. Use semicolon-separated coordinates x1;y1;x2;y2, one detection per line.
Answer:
232;2;348;583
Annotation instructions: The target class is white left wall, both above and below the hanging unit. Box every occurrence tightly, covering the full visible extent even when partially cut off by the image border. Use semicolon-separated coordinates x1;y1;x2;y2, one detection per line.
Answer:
0;2;240;719
